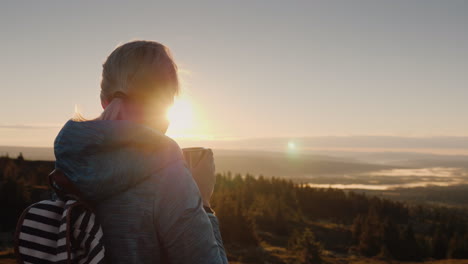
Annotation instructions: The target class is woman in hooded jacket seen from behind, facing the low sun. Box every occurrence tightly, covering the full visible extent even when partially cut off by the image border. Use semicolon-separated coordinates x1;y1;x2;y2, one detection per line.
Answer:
54;41;227;263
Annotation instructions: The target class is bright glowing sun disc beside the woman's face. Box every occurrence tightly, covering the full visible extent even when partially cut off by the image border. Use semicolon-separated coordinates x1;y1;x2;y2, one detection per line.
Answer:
167;98;193;134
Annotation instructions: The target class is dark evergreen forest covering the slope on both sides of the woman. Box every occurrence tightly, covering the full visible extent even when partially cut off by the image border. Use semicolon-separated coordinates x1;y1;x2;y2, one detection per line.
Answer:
0;155;468;263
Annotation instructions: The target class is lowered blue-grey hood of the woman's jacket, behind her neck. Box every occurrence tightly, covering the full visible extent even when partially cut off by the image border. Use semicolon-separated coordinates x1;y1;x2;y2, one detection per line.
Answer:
54;120;183;201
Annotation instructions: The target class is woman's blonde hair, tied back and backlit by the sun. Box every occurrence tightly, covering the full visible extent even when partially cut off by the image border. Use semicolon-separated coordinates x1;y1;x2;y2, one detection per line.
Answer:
75;40;180;120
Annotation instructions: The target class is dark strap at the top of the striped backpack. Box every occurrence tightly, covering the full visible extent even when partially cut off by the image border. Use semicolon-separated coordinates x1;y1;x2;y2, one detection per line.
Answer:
49;168;94;212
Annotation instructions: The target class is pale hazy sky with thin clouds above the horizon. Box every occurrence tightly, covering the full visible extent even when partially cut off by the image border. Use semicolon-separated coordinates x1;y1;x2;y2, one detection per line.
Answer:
0;0;468;150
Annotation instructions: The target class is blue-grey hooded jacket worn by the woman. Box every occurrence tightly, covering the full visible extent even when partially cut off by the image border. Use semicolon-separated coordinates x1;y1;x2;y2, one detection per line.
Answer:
54;120;228;264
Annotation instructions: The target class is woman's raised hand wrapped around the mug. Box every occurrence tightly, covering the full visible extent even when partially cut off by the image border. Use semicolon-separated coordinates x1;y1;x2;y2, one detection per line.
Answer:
192;149;216;207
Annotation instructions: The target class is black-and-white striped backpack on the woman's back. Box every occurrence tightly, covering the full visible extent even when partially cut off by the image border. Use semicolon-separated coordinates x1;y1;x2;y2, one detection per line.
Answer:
15;169;105;264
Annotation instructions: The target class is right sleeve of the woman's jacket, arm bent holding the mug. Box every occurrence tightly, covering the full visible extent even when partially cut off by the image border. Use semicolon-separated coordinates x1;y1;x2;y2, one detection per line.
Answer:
153;160;228;264
